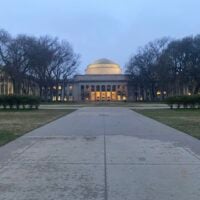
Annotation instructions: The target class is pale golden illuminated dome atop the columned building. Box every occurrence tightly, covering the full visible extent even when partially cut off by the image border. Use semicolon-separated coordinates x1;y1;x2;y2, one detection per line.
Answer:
85;58;122;75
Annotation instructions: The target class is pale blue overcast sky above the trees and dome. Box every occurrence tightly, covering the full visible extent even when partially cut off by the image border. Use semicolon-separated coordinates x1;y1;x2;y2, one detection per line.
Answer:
0;0;200;73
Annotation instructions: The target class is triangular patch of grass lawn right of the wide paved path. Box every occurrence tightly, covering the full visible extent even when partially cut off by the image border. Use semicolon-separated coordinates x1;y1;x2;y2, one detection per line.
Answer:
134;109;200;139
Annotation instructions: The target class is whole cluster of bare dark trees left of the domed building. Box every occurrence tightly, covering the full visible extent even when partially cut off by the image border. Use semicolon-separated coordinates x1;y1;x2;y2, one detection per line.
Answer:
0;30;79;100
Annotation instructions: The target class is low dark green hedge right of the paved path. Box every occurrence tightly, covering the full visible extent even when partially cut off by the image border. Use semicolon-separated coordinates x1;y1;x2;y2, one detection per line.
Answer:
165;95;200;109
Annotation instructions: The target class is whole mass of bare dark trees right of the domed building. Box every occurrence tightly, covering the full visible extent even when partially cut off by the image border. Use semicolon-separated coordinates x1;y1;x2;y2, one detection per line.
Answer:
126;35;200;100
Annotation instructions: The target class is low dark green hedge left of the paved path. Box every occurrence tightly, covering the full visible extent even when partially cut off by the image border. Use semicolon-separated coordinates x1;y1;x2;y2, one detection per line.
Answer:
0;95;40;109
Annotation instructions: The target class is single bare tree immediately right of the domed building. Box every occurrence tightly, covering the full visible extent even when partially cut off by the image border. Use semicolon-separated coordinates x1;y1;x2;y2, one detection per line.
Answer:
126;38;170;100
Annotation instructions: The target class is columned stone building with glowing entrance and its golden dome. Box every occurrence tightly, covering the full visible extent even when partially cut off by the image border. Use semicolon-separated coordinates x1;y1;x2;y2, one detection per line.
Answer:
66;58;128;101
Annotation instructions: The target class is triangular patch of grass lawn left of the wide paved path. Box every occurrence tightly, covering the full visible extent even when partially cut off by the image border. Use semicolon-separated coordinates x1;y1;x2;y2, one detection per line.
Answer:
0;110;74;146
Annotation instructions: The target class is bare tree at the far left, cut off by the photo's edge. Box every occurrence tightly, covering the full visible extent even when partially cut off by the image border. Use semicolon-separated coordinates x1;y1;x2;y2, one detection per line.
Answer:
0;31;32;94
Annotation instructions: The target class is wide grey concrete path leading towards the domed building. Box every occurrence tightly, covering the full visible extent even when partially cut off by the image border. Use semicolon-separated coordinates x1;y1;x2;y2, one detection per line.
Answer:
0;108;200;200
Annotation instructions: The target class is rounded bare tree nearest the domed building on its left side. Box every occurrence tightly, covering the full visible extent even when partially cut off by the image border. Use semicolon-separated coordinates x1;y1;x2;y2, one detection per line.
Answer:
30;36;79;100
